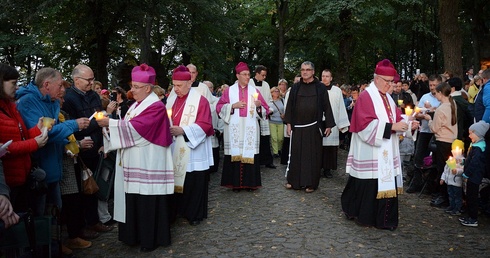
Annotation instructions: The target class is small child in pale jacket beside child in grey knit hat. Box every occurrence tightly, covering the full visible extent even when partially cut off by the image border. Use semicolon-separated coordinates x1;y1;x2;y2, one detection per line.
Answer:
440;140;464;216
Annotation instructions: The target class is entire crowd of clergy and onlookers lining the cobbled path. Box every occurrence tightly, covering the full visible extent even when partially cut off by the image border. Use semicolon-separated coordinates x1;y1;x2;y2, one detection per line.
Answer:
0;59;490;255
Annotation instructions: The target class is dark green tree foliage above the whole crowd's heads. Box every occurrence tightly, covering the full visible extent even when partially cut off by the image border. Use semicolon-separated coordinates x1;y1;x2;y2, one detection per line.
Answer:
0;0;490;88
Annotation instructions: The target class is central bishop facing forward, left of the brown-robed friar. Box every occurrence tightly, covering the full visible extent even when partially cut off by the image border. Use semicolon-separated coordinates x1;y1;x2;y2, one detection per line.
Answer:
216;62;269;192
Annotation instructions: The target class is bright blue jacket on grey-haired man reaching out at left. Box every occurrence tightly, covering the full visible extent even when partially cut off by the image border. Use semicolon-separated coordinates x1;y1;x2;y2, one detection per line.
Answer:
16;82;78;183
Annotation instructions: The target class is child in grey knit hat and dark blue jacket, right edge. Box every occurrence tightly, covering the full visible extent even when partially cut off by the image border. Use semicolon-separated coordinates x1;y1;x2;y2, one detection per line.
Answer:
459;120;490;227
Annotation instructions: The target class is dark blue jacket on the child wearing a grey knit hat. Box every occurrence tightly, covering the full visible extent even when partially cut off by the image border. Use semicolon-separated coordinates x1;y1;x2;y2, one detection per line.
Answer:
463;139;486;185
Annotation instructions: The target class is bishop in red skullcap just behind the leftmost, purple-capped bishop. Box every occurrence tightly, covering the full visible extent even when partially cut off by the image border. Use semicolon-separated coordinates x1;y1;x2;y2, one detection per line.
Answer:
167;65;214;226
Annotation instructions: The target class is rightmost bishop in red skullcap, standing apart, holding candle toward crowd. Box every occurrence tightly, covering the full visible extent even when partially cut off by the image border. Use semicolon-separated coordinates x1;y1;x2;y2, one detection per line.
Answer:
341;59;418;230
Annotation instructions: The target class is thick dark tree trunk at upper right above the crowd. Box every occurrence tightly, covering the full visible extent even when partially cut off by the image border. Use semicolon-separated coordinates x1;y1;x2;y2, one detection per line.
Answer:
439;0;463;78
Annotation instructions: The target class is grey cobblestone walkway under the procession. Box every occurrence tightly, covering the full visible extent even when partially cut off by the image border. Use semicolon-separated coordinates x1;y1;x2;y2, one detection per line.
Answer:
75;150;490;257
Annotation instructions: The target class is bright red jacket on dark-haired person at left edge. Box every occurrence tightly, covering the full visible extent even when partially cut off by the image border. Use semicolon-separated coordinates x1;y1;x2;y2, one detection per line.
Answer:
0;99;41;187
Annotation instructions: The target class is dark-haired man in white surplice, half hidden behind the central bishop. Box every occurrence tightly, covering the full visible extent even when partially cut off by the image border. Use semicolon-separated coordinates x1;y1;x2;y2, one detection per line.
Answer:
249;65;279;168
